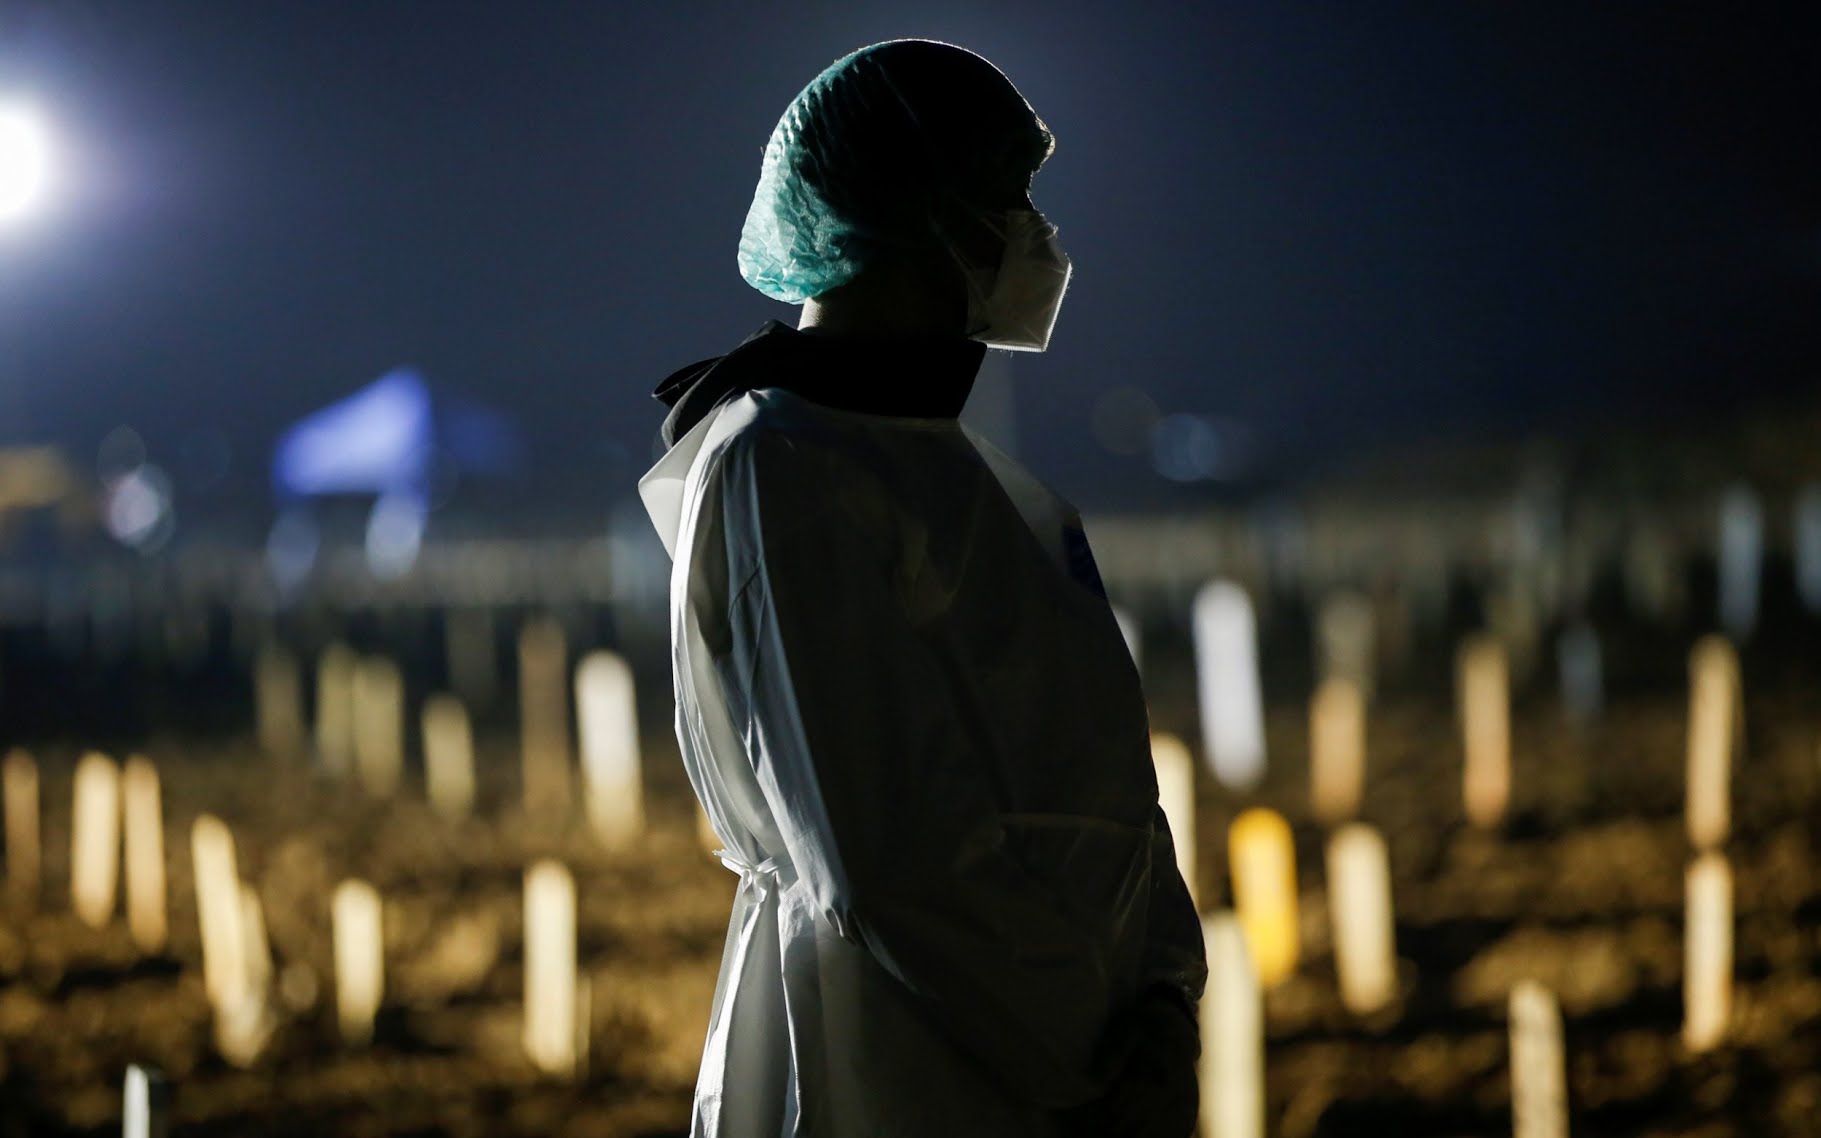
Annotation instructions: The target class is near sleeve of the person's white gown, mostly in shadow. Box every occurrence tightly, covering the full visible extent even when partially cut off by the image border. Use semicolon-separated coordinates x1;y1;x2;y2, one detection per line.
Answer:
695;424;1121;1107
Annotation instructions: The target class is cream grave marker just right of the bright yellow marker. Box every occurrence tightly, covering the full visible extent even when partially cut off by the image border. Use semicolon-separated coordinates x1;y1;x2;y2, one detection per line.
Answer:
1328;823;1397;1016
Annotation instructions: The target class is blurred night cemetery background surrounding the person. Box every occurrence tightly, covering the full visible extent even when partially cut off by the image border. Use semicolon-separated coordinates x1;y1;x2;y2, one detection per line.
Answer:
0;0;1821;1138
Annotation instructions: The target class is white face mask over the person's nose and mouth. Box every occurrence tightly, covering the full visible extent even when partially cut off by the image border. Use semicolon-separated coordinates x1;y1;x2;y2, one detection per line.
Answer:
961;209;1074;351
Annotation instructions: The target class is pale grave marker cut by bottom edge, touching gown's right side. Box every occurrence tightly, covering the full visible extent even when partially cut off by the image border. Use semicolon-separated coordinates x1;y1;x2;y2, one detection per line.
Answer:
1200;912;1264;1138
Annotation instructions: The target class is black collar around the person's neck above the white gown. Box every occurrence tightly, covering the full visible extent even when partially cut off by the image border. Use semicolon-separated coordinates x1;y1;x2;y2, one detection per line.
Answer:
652;320;987;450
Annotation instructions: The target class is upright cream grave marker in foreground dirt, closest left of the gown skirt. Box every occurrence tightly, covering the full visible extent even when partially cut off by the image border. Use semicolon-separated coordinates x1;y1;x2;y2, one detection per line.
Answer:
524;859;575;1078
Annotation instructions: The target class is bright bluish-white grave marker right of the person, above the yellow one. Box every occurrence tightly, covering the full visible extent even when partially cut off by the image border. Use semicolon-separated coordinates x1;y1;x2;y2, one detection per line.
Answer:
1195;581;1264;790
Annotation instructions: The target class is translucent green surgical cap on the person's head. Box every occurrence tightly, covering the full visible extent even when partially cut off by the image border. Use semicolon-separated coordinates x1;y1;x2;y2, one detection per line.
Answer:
739;40;1054;304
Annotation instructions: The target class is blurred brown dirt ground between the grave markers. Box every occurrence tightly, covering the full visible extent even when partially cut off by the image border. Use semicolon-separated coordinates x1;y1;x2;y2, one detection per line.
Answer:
0;622;1821;1138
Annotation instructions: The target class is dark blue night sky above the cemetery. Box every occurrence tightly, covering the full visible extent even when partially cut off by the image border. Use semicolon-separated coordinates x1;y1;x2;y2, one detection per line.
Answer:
0;0;1821;531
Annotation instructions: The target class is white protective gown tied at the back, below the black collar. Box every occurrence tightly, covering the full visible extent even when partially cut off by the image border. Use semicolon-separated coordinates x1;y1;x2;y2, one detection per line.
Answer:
639;376;1206;1138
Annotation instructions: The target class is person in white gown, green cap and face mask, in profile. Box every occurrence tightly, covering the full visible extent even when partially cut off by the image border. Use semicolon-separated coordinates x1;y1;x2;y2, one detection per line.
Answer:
639;40;1206;1138
